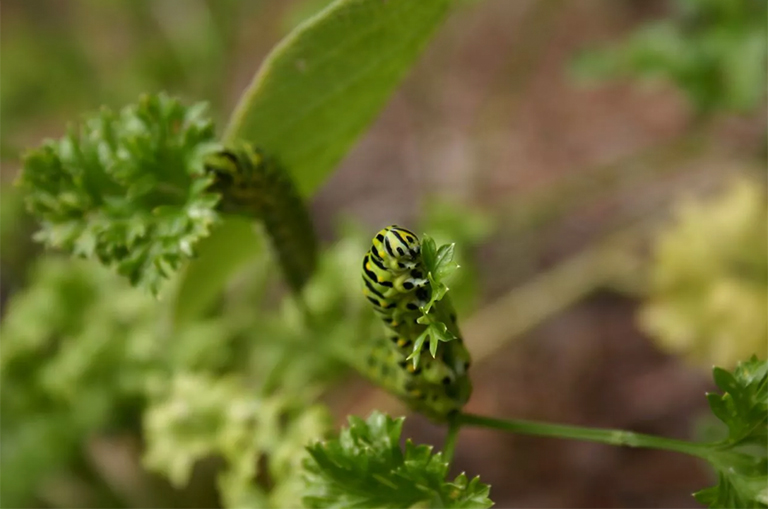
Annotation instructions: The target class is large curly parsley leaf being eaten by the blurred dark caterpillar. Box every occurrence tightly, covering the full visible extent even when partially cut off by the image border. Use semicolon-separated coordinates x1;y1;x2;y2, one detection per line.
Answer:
18;94;219;294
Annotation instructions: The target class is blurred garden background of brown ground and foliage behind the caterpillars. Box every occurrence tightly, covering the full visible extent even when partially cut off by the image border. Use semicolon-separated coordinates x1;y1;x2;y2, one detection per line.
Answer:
0;0;768;507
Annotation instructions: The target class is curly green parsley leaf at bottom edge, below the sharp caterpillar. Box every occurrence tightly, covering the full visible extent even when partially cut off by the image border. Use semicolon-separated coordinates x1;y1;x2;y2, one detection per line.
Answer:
304;412;493;508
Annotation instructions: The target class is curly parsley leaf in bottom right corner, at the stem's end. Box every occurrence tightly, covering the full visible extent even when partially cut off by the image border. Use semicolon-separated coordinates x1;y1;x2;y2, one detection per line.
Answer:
694;357;768;508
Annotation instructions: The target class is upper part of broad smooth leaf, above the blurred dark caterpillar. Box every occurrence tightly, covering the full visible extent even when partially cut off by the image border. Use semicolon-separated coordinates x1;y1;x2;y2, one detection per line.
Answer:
225;0;454;195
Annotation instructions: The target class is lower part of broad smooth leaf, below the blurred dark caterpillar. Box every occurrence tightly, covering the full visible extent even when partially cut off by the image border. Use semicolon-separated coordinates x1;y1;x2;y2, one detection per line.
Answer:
173;216;263;324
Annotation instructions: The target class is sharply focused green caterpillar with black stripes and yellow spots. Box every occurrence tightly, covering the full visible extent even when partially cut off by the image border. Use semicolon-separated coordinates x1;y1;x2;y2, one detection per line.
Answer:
363;226;472;421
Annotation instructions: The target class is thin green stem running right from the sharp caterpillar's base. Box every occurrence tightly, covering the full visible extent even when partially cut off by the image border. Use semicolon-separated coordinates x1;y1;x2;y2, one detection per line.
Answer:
457;414;708;459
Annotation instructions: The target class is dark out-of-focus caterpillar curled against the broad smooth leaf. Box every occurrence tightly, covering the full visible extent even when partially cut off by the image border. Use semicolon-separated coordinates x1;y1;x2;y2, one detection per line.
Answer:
206;142;318;292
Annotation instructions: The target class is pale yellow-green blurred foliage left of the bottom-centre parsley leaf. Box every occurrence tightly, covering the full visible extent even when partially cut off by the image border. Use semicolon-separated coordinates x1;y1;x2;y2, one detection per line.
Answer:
144;372;330;507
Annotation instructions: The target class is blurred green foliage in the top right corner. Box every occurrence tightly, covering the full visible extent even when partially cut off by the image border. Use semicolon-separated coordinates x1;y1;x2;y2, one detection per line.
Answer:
577;0;768;113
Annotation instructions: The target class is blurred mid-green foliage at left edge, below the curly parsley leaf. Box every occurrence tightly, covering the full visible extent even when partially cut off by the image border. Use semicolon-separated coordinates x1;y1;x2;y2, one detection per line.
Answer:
0;257;243;507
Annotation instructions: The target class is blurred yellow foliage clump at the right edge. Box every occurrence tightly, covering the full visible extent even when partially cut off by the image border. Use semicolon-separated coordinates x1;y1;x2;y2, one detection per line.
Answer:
640;178;768;366
